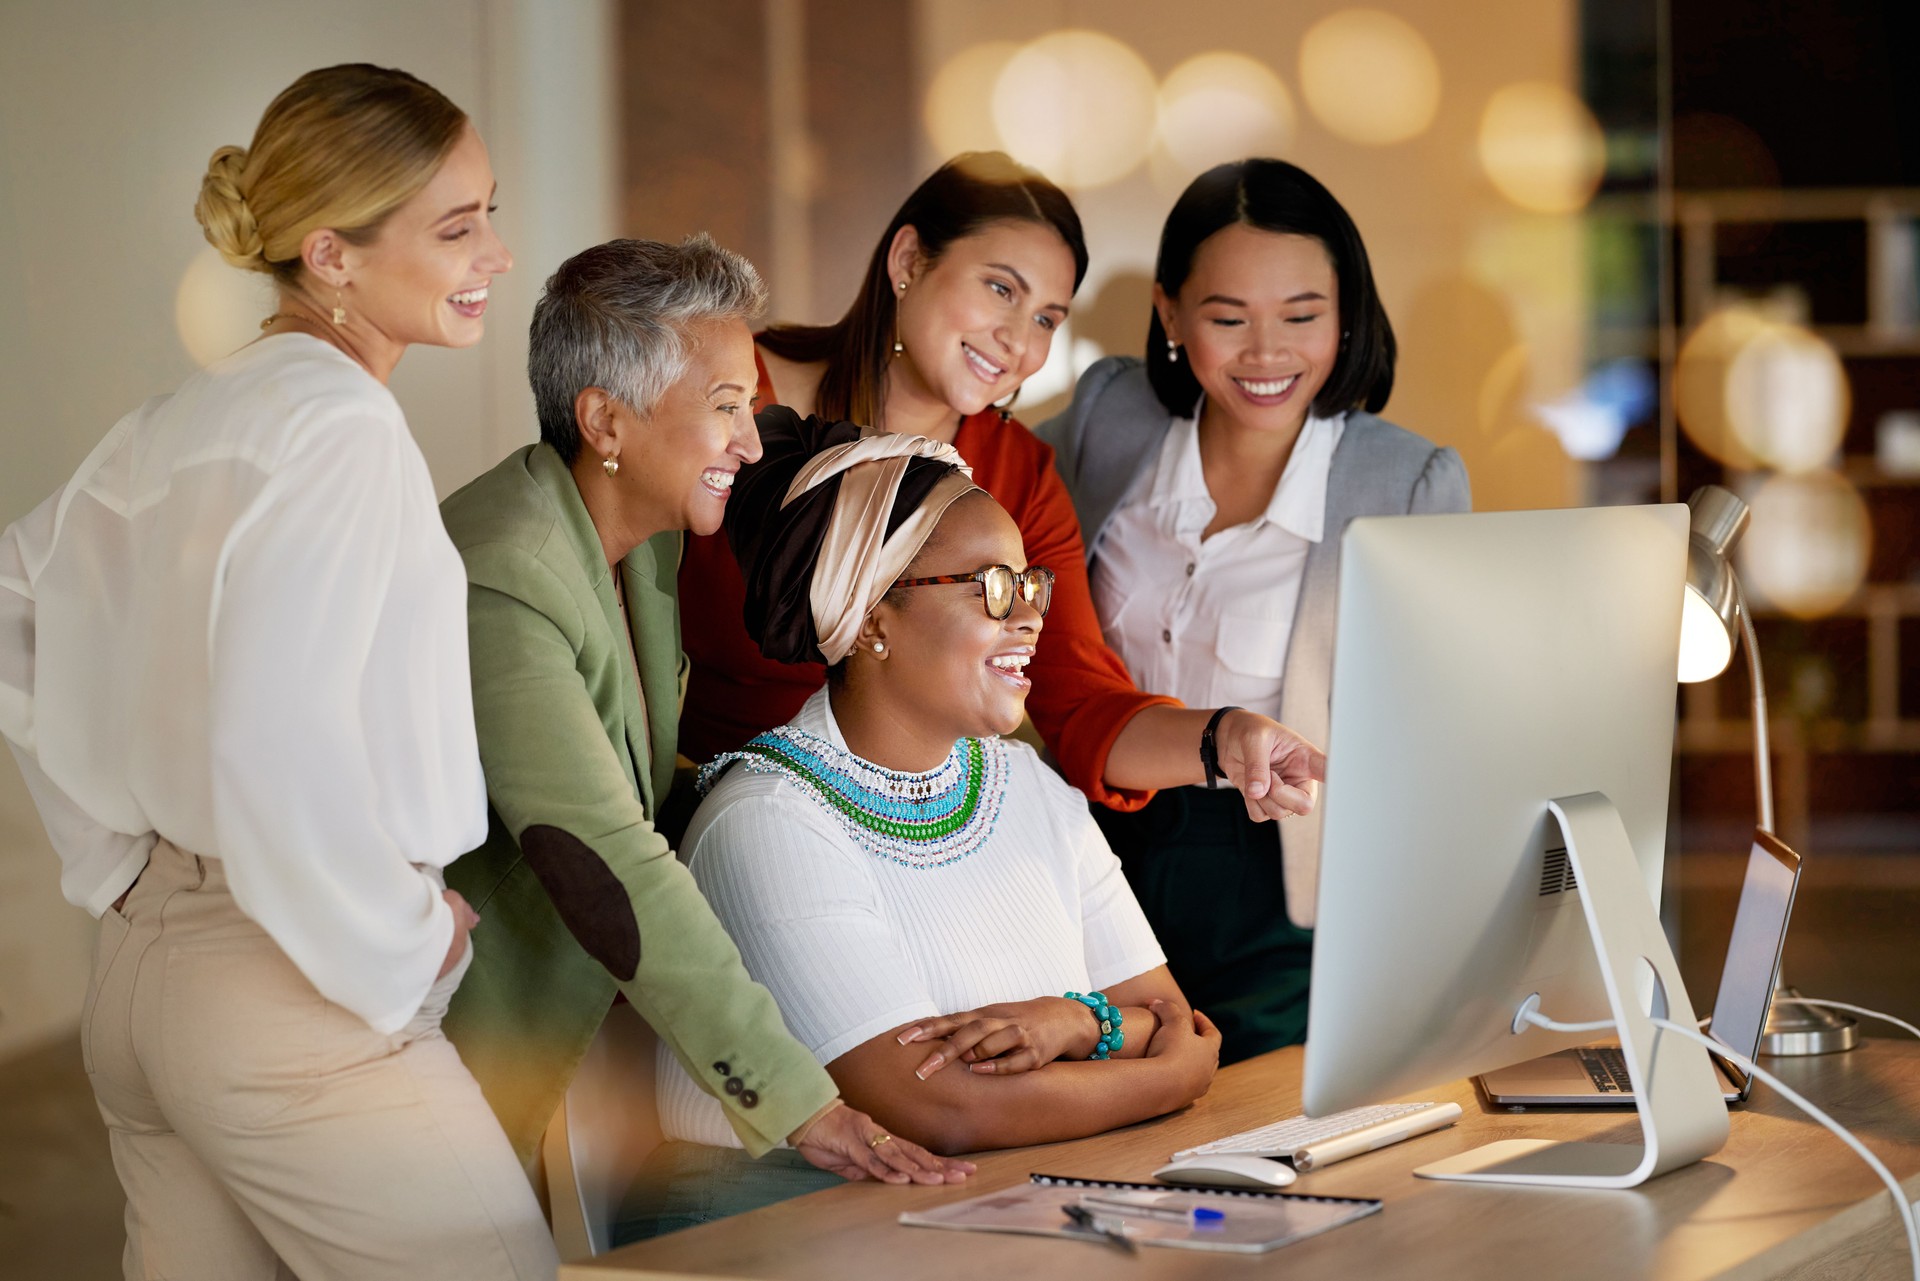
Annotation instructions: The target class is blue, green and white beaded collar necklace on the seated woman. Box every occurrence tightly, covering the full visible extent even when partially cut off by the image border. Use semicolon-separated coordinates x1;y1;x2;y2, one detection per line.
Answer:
699;726;1006;868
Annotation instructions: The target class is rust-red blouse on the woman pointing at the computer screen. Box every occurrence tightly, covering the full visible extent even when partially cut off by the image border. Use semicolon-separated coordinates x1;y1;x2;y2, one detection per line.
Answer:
680;353;1181;810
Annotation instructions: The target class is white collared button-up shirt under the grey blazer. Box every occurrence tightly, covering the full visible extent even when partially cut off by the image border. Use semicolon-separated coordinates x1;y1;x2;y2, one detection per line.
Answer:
1090;411;1346;718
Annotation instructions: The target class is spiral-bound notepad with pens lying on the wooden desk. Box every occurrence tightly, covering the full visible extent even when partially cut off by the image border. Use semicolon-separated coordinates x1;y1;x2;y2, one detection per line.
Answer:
900;1173;1380;1254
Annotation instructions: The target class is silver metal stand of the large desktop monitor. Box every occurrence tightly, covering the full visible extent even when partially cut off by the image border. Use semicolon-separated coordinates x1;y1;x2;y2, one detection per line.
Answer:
1413;791;1728;1187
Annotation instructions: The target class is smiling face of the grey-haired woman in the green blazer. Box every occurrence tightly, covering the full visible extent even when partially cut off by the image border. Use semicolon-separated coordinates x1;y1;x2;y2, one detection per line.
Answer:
618;319;760;534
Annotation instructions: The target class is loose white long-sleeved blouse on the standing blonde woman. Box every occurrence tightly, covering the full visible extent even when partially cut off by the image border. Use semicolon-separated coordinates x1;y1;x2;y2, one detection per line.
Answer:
0;334;486;1031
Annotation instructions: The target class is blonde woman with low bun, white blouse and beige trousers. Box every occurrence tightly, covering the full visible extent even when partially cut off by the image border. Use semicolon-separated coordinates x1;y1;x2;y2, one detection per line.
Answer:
0;65;555;1281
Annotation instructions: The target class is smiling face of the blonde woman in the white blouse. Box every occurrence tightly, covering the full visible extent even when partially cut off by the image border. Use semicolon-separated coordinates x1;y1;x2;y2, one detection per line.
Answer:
334;125;513;348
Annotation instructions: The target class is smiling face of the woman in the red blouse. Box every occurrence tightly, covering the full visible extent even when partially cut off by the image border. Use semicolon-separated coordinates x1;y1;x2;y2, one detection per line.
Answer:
887;221;1073;417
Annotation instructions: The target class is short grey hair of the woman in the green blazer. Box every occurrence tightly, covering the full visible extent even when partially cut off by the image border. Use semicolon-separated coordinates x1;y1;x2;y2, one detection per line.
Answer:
526;232;766;463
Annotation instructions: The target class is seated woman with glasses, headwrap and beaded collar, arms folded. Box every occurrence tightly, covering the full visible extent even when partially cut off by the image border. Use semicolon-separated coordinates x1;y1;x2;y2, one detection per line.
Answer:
628;409;1219;1235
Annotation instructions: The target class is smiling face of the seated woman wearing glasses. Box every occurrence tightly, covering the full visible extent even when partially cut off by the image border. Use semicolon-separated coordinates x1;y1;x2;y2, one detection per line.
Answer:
870;494;1043;743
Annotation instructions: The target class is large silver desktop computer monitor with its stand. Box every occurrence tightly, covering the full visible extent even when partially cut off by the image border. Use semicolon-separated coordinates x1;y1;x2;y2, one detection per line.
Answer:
1304;503;1728;1187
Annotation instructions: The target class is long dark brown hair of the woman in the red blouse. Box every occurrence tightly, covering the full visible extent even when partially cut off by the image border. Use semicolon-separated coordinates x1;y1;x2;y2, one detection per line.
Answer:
760;152;1087;424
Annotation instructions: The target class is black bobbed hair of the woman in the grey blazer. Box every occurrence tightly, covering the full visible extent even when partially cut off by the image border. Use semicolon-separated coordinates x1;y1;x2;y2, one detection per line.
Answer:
1146;159;1398;417
